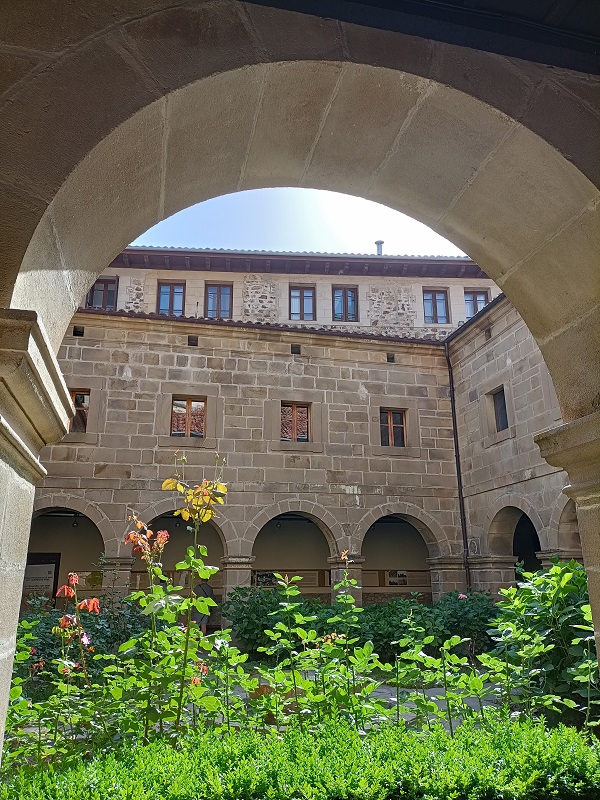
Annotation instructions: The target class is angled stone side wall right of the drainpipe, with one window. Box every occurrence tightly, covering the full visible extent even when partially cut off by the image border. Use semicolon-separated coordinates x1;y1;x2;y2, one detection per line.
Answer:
450;300;581;586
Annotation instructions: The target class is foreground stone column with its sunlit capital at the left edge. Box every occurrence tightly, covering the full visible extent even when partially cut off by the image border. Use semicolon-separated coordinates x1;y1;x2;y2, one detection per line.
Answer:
0;309;73;752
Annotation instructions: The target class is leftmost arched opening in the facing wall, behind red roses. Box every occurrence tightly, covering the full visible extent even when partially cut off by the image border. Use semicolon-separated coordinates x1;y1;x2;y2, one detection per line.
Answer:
23;506;105;598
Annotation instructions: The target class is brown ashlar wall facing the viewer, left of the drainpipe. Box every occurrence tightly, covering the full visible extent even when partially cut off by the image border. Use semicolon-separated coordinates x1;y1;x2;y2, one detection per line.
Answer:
37;313;462;593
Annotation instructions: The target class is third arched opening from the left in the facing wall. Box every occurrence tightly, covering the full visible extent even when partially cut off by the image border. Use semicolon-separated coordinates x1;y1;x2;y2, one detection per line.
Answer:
252;513;331;601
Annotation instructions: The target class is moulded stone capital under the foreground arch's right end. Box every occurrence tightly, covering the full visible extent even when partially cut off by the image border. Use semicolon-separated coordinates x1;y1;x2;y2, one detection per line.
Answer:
534;410;600;502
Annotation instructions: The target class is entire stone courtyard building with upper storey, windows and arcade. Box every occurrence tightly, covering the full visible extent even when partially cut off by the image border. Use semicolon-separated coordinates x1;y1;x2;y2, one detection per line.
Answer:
26;250;580;602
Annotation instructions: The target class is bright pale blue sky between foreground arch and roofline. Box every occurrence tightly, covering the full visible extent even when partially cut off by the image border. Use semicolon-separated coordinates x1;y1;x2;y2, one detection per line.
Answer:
132;189;463;256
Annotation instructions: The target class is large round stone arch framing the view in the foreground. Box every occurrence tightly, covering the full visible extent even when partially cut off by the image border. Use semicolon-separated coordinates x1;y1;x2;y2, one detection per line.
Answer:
0;0;600;420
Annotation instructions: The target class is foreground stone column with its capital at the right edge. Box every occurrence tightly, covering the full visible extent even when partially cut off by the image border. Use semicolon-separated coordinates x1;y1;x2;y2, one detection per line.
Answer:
535;411;600;653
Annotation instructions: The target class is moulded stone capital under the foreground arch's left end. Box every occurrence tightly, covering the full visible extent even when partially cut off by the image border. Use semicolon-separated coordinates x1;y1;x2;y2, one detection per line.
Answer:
0;309;73;466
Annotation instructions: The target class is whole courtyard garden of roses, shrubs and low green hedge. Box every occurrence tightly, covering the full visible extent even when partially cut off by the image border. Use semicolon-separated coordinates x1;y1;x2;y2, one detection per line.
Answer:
0;463;600;800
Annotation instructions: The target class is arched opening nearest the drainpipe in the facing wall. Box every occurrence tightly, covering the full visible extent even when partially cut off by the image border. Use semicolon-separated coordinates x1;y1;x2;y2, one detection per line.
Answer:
362;514;431;604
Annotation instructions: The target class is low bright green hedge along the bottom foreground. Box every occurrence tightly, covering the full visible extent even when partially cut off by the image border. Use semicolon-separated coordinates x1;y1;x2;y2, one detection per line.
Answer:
0;718;600;800
